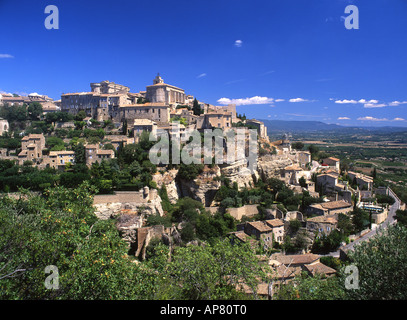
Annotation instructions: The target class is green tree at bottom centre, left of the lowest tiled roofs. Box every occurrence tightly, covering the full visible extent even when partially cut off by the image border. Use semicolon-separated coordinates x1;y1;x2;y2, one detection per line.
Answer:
169;239;265;300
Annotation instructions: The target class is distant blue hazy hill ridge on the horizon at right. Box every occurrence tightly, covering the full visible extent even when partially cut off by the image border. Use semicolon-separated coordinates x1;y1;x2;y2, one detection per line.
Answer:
261;119;407;133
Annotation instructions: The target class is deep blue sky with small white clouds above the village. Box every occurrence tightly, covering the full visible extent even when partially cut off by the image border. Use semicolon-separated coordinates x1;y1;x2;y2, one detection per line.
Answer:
0;0;407;127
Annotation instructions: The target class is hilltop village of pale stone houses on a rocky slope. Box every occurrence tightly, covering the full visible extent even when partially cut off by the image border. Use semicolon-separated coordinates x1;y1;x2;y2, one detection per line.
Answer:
0;75;405;296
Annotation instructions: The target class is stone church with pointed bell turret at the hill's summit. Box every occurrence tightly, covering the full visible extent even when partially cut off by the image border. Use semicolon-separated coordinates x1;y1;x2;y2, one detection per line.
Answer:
146;74;186;105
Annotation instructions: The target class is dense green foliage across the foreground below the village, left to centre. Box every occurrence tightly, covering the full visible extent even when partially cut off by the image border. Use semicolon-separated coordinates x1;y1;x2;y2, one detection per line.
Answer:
0;183;264;299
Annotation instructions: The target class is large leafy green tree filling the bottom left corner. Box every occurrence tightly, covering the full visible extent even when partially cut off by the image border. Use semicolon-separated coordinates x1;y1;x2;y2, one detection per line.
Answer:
0;184;162;300
